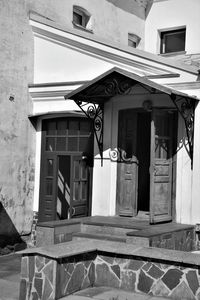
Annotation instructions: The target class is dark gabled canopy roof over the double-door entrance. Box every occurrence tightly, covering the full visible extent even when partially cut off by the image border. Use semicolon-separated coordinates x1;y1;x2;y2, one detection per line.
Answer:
65;67;198;104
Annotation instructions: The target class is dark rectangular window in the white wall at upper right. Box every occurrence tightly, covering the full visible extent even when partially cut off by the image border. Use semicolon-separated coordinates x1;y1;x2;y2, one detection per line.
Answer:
160;28;186;54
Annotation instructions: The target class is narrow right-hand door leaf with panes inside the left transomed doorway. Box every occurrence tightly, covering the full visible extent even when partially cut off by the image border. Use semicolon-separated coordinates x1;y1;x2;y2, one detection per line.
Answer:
70;156;90;218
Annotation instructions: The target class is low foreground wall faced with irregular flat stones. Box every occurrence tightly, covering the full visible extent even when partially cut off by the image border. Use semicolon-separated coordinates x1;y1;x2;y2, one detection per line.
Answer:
20;242;200;300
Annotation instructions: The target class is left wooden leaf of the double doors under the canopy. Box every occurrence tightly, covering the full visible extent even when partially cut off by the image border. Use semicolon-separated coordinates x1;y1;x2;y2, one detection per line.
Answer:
116;110;138;216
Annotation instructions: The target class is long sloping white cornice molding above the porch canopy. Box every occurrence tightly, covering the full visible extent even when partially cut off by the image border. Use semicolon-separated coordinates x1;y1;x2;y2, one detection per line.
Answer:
30;14;198;75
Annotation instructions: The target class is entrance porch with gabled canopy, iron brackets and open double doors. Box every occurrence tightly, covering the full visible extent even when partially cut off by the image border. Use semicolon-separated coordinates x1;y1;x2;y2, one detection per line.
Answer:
66;68;196;224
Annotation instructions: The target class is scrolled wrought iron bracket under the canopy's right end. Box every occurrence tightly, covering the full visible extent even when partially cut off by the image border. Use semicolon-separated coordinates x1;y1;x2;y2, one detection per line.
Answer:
171;94;195;167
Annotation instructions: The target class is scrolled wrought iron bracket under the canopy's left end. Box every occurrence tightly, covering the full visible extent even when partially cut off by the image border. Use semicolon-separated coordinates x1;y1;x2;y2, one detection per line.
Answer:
74;100;104;165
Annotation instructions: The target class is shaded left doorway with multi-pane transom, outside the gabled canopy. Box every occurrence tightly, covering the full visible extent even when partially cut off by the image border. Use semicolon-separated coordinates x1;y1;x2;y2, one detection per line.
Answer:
39;117;93;222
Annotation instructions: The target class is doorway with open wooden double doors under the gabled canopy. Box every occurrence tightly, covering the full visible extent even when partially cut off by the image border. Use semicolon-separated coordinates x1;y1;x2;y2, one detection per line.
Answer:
116;109;177;223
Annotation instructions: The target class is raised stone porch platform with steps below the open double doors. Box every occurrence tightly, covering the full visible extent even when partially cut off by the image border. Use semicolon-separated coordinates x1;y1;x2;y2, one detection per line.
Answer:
37;216;195;251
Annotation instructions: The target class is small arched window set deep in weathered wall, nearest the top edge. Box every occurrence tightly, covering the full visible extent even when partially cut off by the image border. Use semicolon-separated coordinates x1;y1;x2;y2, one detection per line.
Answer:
72;5;92;31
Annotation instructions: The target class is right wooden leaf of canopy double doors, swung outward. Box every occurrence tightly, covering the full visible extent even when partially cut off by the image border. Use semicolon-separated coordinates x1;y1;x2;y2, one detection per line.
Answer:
150;110;174;224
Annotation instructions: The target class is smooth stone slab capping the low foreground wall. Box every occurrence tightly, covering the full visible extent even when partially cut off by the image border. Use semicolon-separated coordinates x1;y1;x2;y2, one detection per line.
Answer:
18;240;200;266
